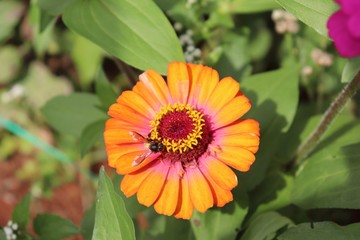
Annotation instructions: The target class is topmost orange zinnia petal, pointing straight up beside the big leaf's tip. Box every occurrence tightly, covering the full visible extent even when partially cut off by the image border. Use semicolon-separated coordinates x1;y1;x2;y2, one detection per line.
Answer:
167;62;190;103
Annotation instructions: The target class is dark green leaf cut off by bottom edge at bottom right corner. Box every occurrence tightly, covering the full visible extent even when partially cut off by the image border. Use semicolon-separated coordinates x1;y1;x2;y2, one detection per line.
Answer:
278;222;360;240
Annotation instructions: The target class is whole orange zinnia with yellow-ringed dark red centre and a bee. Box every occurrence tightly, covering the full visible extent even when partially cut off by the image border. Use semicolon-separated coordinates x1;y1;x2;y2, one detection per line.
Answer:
104;62;259;219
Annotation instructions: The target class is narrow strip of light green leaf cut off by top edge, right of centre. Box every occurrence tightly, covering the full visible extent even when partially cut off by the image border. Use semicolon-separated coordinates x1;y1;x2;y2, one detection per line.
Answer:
219;0;280;13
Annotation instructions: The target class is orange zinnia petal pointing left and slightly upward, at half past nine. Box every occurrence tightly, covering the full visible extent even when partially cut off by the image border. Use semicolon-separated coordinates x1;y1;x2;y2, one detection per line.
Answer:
108;103;150;127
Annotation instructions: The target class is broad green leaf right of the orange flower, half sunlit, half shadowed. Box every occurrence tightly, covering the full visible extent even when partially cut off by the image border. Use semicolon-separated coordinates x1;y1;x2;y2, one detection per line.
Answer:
239;66;299;189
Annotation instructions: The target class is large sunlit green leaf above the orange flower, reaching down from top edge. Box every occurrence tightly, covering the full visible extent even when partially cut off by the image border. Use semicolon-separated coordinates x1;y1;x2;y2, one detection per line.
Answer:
63;0;184;74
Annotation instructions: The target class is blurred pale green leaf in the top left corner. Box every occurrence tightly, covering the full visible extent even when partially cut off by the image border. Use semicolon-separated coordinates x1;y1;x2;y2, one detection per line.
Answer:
0;1;25;43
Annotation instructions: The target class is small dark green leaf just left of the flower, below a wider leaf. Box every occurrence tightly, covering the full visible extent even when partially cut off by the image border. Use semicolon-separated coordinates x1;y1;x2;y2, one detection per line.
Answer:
80;119;106;158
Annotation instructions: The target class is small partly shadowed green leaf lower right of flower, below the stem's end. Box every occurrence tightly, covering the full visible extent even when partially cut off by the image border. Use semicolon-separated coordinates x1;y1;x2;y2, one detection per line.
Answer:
250;172;294;217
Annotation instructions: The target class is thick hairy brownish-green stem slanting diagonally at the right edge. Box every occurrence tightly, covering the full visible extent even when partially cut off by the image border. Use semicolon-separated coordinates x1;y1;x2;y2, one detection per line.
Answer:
294;72;360;166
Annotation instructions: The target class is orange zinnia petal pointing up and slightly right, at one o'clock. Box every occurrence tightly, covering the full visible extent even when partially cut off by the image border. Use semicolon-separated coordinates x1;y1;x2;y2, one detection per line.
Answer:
189;67;219;108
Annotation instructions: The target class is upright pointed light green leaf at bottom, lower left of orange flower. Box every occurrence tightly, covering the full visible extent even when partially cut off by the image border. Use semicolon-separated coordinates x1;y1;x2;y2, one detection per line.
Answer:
93;167;135;240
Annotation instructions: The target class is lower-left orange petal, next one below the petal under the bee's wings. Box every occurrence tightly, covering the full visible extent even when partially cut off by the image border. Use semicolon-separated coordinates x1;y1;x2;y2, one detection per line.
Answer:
120;164;153;197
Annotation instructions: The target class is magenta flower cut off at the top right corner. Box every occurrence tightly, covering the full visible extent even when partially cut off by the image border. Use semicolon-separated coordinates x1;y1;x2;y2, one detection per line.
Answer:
327;0;360;58
